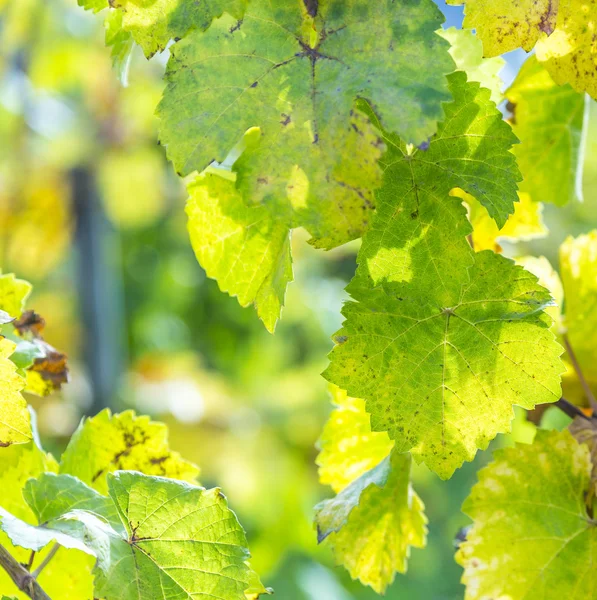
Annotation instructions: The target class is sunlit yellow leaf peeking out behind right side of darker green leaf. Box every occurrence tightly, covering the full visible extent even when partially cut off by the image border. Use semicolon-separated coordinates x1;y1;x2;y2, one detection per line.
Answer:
451;189;548;252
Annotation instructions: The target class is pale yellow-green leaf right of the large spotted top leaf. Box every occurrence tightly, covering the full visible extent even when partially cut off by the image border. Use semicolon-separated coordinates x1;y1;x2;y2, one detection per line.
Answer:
438;27;506;104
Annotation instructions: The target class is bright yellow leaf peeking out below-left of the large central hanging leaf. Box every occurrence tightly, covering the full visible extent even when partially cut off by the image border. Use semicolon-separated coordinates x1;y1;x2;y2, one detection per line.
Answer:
316;385;393;493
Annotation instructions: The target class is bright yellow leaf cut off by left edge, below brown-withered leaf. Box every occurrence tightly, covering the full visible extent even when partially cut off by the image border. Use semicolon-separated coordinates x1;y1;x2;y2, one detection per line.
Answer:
0;336;32;447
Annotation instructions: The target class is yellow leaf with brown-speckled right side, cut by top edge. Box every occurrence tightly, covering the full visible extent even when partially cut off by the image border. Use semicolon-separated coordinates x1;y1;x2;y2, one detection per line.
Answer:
447;0;558;56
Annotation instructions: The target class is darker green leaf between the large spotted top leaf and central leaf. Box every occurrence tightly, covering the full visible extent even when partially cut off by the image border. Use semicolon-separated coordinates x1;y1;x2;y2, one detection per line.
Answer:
349;72;520;297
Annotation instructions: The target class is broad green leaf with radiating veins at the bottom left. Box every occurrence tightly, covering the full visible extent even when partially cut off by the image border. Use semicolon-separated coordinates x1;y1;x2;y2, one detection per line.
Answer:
87;471;252;600
